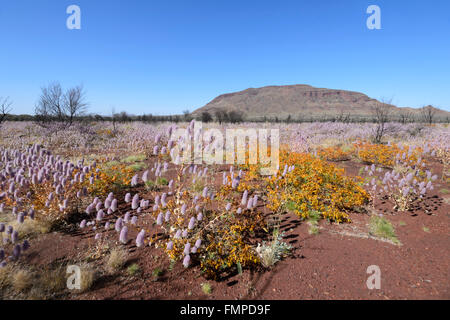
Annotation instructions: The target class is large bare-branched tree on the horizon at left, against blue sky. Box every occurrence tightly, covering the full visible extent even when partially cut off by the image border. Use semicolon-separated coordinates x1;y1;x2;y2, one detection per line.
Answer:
34;82;87;127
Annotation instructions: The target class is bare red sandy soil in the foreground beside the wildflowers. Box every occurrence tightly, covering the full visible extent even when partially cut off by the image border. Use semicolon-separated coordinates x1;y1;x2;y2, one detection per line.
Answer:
14;162;450;300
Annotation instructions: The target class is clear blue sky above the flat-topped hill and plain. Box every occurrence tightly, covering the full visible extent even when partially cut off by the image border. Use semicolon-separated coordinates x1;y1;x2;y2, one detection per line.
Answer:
0;0;450;114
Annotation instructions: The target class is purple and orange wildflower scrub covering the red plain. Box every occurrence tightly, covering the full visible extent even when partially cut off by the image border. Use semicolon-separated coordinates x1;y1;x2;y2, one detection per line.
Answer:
0;118;450;298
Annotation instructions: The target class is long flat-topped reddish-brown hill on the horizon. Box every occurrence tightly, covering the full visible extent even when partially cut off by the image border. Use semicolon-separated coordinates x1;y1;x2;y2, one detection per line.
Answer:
193;84;450;119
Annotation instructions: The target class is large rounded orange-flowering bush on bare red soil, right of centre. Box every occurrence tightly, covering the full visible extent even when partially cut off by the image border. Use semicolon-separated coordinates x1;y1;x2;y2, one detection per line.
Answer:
267;151;370;222
